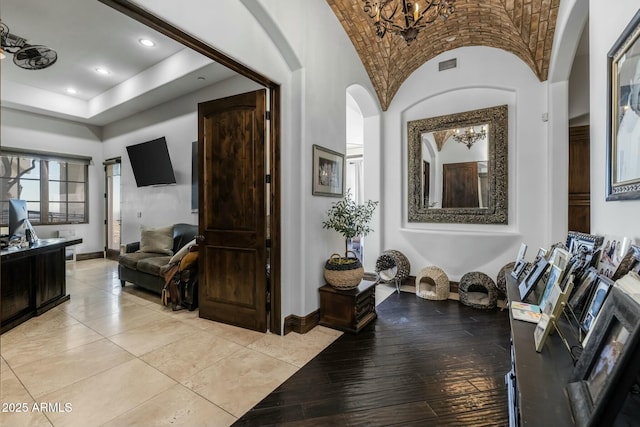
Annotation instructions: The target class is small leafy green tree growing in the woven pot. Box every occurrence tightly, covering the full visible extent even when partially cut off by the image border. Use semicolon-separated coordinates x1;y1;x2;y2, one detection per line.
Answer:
322;189;378;257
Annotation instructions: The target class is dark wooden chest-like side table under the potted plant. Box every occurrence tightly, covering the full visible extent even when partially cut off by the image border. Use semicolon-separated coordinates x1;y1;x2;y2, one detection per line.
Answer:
320;280;377;334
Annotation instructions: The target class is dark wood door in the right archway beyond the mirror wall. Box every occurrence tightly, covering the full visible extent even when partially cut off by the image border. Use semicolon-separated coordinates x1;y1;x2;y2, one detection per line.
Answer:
569;126;591;234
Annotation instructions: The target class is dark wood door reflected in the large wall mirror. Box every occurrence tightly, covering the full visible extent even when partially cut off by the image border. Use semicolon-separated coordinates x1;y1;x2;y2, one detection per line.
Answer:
442;162;480;208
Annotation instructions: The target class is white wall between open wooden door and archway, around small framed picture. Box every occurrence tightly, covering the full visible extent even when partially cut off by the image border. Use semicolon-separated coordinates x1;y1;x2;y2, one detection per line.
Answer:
132;0;378;319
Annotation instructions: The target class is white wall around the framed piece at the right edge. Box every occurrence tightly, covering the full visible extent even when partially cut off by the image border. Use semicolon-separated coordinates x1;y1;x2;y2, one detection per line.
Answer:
589;0;640;242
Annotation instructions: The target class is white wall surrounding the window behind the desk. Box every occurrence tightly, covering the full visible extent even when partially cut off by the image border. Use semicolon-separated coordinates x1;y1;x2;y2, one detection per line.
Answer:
0;108;105;253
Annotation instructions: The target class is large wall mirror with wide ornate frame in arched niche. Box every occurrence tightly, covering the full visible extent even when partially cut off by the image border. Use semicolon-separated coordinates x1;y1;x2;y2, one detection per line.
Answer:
407;105;508;224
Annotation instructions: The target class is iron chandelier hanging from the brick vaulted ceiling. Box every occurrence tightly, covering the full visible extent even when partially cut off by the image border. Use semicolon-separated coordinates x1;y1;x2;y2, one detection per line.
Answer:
363;0;455;45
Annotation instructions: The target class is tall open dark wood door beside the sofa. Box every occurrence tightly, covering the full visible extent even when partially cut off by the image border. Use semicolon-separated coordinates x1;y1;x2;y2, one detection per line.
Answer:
198;90;268;331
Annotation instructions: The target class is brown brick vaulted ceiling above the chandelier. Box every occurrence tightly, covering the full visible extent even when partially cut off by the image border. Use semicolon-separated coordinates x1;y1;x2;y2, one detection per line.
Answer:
327;0;560;111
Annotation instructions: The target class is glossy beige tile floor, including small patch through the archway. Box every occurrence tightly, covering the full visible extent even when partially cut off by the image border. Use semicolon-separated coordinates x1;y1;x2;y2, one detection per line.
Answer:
0;259;394;427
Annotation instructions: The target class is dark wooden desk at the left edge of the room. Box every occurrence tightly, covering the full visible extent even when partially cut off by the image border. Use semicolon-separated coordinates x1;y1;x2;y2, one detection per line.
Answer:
0;239;82;333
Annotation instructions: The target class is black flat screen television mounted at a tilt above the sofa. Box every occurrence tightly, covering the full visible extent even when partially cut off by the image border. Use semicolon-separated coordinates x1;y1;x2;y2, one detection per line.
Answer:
127;136;176;187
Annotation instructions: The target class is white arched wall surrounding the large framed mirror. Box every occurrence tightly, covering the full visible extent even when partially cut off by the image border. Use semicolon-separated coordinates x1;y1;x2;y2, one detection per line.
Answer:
382;47;549;280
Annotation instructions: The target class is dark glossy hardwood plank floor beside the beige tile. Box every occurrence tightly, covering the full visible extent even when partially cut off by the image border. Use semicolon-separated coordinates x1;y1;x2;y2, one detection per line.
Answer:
234;293;510;427
